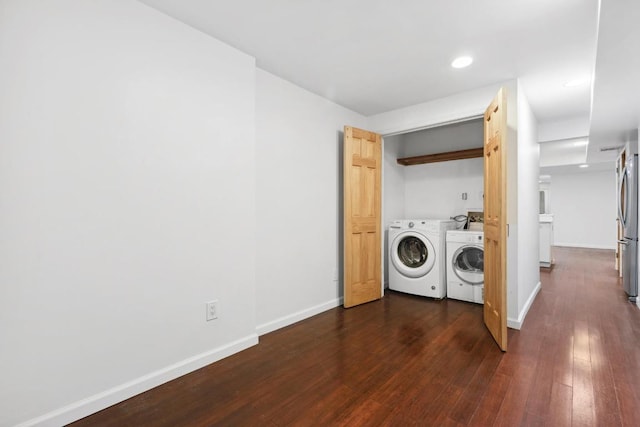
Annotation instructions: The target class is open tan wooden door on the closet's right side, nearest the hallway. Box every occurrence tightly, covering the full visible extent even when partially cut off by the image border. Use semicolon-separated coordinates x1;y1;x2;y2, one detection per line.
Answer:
484;88;507;351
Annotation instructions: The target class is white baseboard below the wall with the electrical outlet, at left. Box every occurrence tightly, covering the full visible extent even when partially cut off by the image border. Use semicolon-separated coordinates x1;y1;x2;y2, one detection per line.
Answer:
16;334;258;427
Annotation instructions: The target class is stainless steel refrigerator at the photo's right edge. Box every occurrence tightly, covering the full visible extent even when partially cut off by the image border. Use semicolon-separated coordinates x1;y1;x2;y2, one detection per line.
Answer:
618;154;638;302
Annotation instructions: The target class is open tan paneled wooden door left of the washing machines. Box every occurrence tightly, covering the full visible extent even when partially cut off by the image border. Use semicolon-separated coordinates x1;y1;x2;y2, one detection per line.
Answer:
343;126;382;307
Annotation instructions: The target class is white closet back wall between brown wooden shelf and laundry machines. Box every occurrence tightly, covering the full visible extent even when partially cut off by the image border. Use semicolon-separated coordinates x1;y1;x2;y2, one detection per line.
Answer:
405;159;484;219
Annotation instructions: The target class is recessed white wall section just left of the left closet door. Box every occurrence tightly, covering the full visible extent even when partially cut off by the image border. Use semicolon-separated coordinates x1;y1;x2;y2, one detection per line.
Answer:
256;69;366;334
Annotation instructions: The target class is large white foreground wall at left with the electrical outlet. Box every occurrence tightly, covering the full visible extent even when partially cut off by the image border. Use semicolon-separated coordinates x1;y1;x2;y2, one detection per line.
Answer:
0;0;258;425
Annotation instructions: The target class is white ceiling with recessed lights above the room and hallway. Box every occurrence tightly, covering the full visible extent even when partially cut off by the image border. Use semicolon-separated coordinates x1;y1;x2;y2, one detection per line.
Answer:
141;0;640;166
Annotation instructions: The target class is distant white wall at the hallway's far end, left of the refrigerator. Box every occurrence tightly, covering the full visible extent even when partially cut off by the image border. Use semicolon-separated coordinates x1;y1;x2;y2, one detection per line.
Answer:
551;170;617;249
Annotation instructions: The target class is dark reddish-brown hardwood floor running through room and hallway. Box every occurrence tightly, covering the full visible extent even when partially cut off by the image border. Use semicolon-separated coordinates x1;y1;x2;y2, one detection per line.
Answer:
74;248;640;427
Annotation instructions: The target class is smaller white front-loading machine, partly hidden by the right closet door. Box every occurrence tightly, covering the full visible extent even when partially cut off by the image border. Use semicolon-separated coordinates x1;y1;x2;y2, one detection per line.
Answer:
447;230;484;304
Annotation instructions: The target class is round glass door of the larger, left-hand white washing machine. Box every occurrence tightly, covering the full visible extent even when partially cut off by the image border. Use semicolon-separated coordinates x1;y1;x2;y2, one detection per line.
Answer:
391;231;436;278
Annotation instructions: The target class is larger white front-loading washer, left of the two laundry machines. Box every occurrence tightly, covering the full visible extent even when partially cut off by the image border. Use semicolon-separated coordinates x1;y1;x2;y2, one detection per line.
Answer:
389;219;455;299
